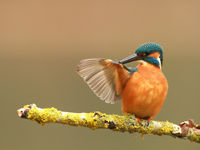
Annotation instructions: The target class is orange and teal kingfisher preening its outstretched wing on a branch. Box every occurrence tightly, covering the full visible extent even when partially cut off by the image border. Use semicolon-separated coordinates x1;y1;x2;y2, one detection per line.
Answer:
77;43;168;123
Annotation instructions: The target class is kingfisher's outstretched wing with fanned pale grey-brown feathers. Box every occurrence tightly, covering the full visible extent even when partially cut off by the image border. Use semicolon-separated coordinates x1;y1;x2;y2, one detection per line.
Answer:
77;58;130;104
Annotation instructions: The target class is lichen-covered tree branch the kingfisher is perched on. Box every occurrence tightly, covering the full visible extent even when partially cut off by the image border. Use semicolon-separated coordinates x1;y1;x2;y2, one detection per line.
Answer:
17;104;200;143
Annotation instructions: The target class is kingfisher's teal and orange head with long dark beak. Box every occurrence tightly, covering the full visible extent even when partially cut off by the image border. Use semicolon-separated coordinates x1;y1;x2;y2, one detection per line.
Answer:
119;43;163;67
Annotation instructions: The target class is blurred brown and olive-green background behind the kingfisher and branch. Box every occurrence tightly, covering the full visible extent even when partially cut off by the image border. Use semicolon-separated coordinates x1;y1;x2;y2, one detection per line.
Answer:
0;0;200;150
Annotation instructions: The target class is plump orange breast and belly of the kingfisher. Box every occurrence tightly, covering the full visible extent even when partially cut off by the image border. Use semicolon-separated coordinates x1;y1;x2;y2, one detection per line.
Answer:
122;63;168;118
